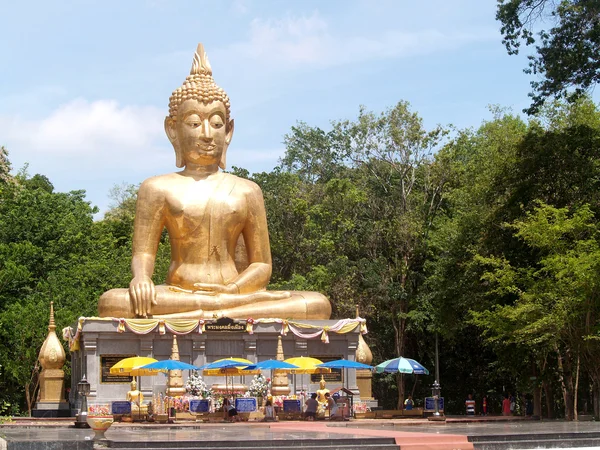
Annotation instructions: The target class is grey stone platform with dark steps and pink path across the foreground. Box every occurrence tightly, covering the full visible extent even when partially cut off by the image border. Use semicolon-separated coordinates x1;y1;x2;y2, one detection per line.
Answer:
5;416;600;450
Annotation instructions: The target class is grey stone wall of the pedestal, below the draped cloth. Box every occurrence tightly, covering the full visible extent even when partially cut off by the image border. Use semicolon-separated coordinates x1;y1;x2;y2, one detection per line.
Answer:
70;318;370;409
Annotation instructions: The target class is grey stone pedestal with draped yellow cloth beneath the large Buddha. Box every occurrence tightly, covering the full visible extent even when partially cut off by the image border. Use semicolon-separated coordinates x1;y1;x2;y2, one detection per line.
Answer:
70;317;364;405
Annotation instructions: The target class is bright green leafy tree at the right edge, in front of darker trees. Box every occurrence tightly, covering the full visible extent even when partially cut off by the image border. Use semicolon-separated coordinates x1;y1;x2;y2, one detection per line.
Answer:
473;203;600;419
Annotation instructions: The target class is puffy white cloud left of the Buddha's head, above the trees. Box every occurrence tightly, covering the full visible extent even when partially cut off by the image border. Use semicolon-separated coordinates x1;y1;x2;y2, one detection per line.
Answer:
0;99;174;204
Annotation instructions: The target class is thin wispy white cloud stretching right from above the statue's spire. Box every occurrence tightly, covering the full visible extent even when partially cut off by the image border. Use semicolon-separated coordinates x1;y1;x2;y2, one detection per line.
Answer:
225;12;497;69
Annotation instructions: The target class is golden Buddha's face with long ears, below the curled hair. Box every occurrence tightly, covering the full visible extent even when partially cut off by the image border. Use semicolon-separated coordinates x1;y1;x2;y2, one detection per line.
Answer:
165;100;233;168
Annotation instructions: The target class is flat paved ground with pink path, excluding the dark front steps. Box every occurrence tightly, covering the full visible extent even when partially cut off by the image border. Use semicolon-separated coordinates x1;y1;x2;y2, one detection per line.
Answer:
0;417;600;449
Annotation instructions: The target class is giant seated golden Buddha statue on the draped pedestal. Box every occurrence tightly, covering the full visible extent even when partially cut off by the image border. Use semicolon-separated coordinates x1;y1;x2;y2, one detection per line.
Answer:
98;44;331;319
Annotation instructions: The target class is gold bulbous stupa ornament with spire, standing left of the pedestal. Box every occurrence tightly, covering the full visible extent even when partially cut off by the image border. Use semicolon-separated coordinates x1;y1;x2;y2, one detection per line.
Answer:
38;302;66;402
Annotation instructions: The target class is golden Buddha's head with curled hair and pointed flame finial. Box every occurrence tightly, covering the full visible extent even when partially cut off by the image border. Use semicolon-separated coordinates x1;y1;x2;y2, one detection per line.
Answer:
165;44;233;169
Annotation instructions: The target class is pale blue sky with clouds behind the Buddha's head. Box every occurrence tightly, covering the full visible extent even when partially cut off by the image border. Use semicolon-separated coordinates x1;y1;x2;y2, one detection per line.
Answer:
0;0;548;211
